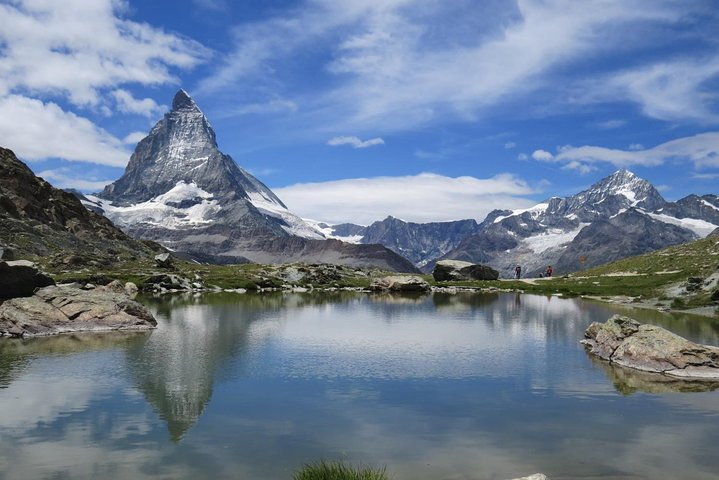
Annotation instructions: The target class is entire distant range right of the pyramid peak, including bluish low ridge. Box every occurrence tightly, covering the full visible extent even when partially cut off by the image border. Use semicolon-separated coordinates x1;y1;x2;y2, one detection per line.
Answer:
324;169;719;277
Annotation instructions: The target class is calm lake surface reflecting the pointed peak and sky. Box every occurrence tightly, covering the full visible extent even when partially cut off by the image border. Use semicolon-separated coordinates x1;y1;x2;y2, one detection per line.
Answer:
0;293;719;480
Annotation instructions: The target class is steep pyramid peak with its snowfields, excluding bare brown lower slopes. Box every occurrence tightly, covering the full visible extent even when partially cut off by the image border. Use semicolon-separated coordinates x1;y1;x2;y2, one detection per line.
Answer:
99;90;324;239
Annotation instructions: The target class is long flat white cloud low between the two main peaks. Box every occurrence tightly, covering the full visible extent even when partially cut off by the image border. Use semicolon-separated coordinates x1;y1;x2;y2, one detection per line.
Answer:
274;173;537;224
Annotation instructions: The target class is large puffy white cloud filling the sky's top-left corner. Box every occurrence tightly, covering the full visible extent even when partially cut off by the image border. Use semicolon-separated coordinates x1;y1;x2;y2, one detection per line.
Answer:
0;0;210;106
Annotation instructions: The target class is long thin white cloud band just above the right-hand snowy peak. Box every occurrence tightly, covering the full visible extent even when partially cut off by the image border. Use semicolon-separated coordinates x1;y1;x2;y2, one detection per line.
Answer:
532;132;719;173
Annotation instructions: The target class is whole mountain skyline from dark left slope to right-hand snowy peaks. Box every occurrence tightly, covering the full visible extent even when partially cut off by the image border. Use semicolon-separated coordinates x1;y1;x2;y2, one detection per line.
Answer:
9;90;708;276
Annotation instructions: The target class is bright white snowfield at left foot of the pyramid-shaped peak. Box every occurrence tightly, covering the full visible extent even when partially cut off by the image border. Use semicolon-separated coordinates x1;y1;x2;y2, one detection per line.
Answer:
86;181;222;230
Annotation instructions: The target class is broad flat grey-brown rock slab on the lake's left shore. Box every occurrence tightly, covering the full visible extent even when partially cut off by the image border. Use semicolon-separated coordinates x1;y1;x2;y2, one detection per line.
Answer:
0;284;157;337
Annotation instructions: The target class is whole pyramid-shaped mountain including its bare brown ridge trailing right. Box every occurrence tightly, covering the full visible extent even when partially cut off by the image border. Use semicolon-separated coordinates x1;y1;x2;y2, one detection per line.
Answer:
86;90;413;270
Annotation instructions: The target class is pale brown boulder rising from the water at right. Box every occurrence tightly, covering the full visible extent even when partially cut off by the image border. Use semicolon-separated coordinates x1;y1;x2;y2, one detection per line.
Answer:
582;315;719;380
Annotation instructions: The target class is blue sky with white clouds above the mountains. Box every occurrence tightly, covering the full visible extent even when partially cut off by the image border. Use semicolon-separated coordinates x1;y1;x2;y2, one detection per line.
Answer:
0;0;719;223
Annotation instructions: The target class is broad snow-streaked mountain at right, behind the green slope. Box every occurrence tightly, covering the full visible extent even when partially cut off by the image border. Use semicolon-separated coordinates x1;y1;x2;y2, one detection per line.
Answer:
443;169;719;276
